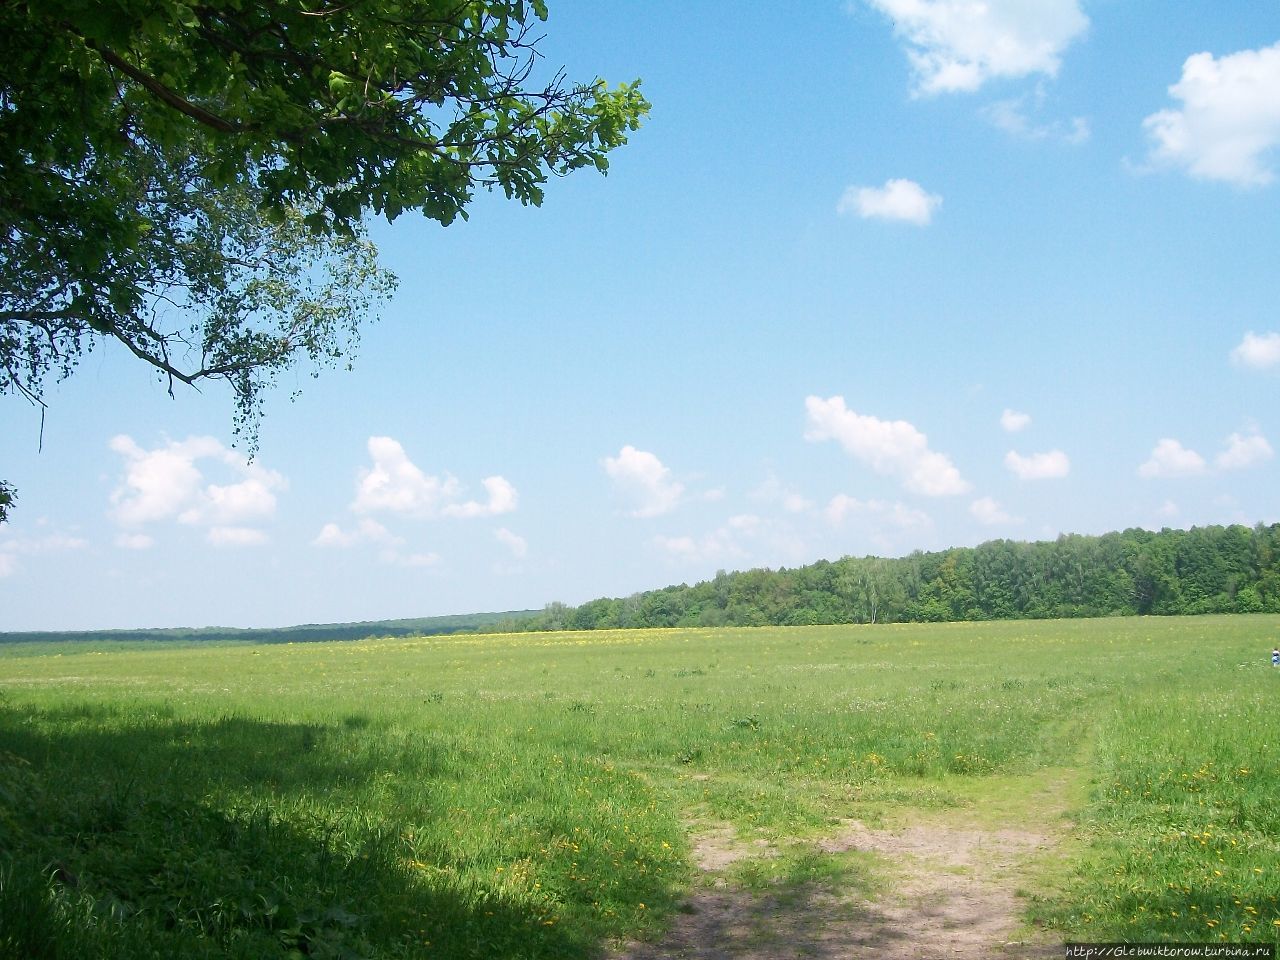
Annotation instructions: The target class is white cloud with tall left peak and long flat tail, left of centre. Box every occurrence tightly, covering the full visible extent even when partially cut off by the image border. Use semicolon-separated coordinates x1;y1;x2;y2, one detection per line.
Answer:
351;436;518;518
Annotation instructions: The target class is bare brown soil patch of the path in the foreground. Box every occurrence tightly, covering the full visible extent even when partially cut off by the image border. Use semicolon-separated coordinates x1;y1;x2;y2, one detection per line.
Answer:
614;820;1062;960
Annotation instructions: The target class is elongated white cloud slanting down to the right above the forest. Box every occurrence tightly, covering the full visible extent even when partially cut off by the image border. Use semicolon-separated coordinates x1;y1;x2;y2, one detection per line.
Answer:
805;397;969;497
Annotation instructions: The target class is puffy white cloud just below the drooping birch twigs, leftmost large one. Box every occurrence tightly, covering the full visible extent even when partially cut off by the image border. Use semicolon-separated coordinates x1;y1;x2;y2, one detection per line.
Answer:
109;434;288;549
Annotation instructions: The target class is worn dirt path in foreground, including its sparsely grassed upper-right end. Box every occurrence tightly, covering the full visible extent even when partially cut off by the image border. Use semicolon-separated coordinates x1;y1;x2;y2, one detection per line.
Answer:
611;769;1079;960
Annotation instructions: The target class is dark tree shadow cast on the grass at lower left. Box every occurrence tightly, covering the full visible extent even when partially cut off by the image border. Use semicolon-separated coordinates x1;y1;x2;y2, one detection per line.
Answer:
0;707;594;960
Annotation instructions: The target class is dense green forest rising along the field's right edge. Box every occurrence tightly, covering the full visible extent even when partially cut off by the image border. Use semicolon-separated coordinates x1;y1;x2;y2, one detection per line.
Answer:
500;524;1280;630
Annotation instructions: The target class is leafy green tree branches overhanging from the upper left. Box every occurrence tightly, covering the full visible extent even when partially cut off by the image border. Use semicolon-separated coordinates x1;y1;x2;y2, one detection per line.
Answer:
0;0;649;504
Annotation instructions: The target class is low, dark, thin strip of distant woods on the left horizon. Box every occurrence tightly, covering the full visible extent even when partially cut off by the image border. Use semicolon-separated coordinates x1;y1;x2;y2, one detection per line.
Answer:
0;611;541;644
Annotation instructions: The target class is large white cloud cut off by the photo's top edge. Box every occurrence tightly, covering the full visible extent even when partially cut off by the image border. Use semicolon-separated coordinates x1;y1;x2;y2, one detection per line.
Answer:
868;0;1089;93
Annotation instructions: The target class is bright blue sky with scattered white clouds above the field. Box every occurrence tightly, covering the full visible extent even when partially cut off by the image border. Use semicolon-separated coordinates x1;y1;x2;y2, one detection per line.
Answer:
0;0;1280;630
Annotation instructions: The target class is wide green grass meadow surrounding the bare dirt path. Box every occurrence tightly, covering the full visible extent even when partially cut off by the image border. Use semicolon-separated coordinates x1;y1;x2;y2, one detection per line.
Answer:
0;616;1280;960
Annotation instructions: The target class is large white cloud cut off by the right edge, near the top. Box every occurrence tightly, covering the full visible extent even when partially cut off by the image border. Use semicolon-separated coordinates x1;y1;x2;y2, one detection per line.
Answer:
1143;44;1280;187
